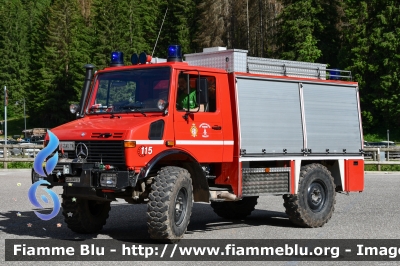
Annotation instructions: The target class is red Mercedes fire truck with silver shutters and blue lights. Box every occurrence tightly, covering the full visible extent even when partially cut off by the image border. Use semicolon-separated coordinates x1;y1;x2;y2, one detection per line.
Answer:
32;45;364;242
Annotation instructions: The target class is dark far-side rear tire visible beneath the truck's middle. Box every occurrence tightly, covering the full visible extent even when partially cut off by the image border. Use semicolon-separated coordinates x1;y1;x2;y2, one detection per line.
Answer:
211;196;258;220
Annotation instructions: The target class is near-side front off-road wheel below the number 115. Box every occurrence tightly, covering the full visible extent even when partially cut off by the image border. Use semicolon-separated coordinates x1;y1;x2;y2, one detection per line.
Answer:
147;166;193;243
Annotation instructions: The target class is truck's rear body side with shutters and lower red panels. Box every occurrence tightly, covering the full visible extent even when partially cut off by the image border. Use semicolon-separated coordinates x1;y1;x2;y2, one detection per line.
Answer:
228;73;364;196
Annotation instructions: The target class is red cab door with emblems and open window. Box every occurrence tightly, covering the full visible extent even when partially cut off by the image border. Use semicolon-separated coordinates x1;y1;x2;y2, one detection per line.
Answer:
174;74;224;162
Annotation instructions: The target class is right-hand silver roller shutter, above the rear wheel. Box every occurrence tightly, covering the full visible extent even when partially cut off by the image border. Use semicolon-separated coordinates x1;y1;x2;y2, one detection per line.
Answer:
303;83;362;154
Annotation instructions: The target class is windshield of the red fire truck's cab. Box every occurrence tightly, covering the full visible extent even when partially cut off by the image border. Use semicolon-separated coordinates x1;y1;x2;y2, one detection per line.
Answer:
87;67;171;114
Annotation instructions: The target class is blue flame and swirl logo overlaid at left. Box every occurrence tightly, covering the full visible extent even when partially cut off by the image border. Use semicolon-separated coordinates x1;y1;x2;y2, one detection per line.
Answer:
28;130;61;221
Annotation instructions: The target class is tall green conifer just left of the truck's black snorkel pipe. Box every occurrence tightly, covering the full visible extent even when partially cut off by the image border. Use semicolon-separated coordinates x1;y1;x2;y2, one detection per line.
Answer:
31;0;90;127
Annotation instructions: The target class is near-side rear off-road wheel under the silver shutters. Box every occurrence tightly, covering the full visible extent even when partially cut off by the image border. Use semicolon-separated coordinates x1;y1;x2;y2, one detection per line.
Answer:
283;163;336;227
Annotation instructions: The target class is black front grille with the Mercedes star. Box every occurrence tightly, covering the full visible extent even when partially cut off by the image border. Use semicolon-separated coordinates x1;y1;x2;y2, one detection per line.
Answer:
63;140;125;165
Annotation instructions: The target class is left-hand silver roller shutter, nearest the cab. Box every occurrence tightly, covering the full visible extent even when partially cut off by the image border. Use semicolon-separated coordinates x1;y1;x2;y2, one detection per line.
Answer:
237;77;303;154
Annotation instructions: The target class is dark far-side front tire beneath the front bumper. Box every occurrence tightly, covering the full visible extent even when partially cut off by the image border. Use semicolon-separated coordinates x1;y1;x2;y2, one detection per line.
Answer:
62;195;111;234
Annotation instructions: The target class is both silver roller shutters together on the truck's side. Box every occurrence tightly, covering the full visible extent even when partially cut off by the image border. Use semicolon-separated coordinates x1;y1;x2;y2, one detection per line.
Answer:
237;76;362;156
